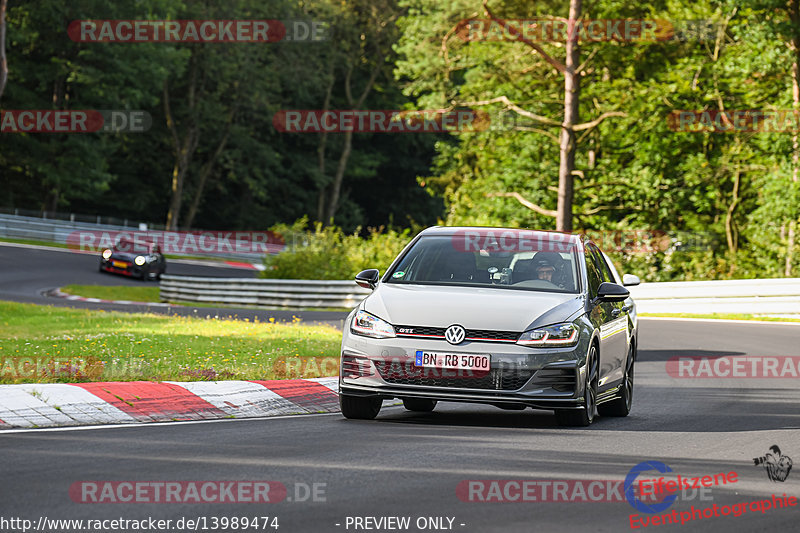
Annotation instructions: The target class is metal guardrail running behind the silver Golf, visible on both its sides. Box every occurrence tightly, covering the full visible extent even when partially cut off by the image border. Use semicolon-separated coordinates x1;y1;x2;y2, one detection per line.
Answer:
161;275;800;315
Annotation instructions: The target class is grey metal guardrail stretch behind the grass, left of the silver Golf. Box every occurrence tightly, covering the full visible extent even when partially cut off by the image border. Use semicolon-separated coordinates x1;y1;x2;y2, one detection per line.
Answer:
161;275;370;309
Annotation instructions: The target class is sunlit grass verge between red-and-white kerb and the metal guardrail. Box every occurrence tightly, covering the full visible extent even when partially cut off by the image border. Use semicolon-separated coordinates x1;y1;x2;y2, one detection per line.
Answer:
0;302;342;383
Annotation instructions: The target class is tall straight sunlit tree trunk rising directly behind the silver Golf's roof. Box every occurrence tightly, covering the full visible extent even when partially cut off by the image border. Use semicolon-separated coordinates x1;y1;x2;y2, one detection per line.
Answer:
556;0;581;232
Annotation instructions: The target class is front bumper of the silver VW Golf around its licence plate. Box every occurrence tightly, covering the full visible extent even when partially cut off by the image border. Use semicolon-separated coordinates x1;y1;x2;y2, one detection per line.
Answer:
339;330;588;409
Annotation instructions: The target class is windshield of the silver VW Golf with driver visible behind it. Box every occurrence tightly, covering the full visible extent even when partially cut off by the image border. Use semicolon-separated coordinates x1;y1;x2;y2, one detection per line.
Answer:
387;232;580;293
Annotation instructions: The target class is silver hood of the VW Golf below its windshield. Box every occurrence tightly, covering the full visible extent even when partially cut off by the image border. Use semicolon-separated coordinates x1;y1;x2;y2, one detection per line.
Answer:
364;283;584;331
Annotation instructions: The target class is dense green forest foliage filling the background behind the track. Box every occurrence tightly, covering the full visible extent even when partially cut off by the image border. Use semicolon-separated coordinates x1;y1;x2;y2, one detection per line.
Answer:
0;0;800;280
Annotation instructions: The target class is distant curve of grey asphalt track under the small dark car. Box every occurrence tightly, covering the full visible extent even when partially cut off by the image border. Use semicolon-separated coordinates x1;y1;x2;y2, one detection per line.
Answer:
0;242;347;324
